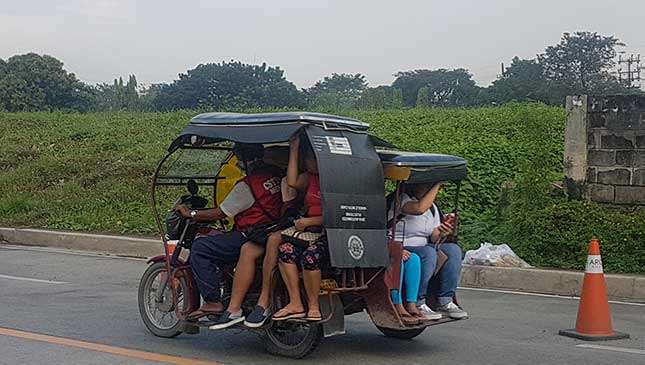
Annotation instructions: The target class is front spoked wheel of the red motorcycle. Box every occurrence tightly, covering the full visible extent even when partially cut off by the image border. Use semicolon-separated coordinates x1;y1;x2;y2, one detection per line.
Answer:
139;262;188;337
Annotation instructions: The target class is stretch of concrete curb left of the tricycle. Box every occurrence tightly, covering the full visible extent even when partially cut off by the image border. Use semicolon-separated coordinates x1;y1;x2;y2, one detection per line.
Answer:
0;227;163;258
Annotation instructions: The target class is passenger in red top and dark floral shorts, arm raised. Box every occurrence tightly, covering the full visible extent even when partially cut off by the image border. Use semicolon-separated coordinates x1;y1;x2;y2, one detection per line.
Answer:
272;137;326;321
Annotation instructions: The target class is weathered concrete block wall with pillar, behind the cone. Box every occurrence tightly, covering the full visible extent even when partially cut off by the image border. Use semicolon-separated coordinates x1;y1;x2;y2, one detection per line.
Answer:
565;95;645;205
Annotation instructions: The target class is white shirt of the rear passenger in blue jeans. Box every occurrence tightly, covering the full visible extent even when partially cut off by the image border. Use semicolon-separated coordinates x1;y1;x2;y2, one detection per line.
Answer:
388;193;441;247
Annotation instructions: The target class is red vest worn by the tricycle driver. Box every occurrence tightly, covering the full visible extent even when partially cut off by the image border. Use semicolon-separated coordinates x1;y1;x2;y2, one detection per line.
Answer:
234;169;282;232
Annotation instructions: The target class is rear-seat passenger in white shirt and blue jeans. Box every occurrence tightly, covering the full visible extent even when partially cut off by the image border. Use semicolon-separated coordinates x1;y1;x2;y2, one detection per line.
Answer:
397;183;468;319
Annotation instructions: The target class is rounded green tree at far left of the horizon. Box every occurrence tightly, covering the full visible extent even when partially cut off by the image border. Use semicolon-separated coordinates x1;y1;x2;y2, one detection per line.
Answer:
0;53;93;112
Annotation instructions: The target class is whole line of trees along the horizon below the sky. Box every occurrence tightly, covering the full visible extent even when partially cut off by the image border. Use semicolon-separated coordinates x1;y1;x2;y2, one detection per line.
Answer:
0;32;641;112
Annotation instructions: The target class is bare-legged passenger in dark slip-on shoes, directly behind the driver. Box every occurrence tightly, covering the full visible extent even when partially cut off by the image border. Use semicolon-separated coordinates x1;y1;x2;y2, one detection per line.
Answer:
210;178;297;329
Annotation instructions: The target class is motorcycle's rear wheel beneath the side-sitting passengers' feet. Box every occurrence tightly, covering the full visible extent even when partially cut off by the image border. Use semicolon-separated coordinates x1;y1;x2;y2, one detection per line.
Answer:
264;272;323;359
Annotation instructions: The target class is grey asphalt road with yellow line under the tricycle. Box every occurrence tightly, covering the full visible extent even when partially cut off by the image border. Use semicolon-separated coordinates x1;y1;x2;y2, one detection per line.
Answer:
0;245;645;364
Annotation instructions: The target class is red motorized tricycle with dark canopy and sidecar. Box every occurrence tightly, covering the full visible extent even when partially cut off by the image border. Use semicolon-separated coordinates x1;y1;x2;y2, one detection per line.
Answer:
138;112;466;358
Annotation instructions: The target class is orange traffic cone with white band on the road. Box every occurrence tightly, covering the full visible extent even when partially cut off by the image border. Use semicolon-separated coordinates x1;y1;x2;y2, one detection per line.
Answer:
560;238;629;341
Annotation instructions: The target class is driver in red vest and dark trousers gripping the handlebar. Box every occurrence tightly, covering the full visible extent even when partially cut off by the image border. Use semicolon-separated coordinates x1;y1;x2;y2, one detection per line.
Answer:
175;143;282;320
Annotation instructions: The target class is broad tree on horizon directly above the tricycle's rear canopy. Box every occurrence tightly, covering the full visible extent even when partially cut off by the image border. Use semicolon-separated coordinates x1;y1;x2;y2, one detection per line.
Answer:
392;68;480;106
